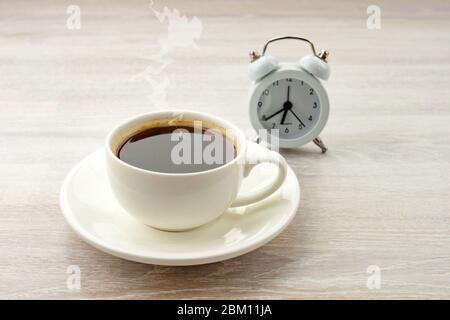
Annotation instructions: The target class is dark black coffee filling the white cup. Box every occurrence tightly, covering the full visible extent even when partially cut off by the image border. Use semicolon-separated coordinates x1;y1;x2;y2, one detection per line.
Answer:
118;126;236;173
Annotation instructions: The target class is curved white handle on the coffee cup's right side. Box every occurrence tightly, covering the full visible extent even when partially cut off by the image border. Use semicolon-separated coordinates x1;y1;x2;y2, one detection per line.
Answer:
230;150;287;208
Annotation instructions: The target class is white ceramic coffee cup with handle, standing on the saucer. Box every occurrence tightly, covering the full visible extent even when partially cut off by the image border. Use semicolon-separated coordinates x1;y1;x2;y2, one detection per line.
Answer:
106;110;287;231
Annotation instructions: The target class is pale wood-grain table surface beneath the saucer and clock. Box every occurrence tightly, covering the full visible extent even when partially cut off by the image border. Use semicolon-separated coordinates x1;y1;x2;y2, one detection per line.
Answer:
0;0;450;299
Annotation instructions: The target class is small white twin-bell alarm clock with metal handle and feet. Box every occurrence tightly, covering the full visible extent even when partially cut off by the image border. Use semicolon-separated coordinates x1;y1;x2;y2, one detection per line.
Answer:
249;37;330;152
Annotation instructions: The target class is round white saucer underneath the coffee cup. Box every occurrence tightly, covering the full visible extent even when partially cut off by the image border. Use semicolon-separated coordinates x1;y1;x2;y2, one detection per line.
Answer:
60;143;300;265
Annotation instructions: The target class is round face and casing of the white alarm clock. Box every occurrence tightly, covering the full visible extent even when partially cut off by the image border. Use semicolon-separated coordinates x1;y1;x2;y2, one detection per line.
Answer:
250;69;329;147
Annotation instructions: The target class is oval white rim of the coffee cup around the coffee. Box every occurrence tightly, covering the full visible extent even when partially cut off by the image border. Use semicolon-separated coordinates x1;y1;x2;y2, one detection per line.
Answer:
105;108;247;177
